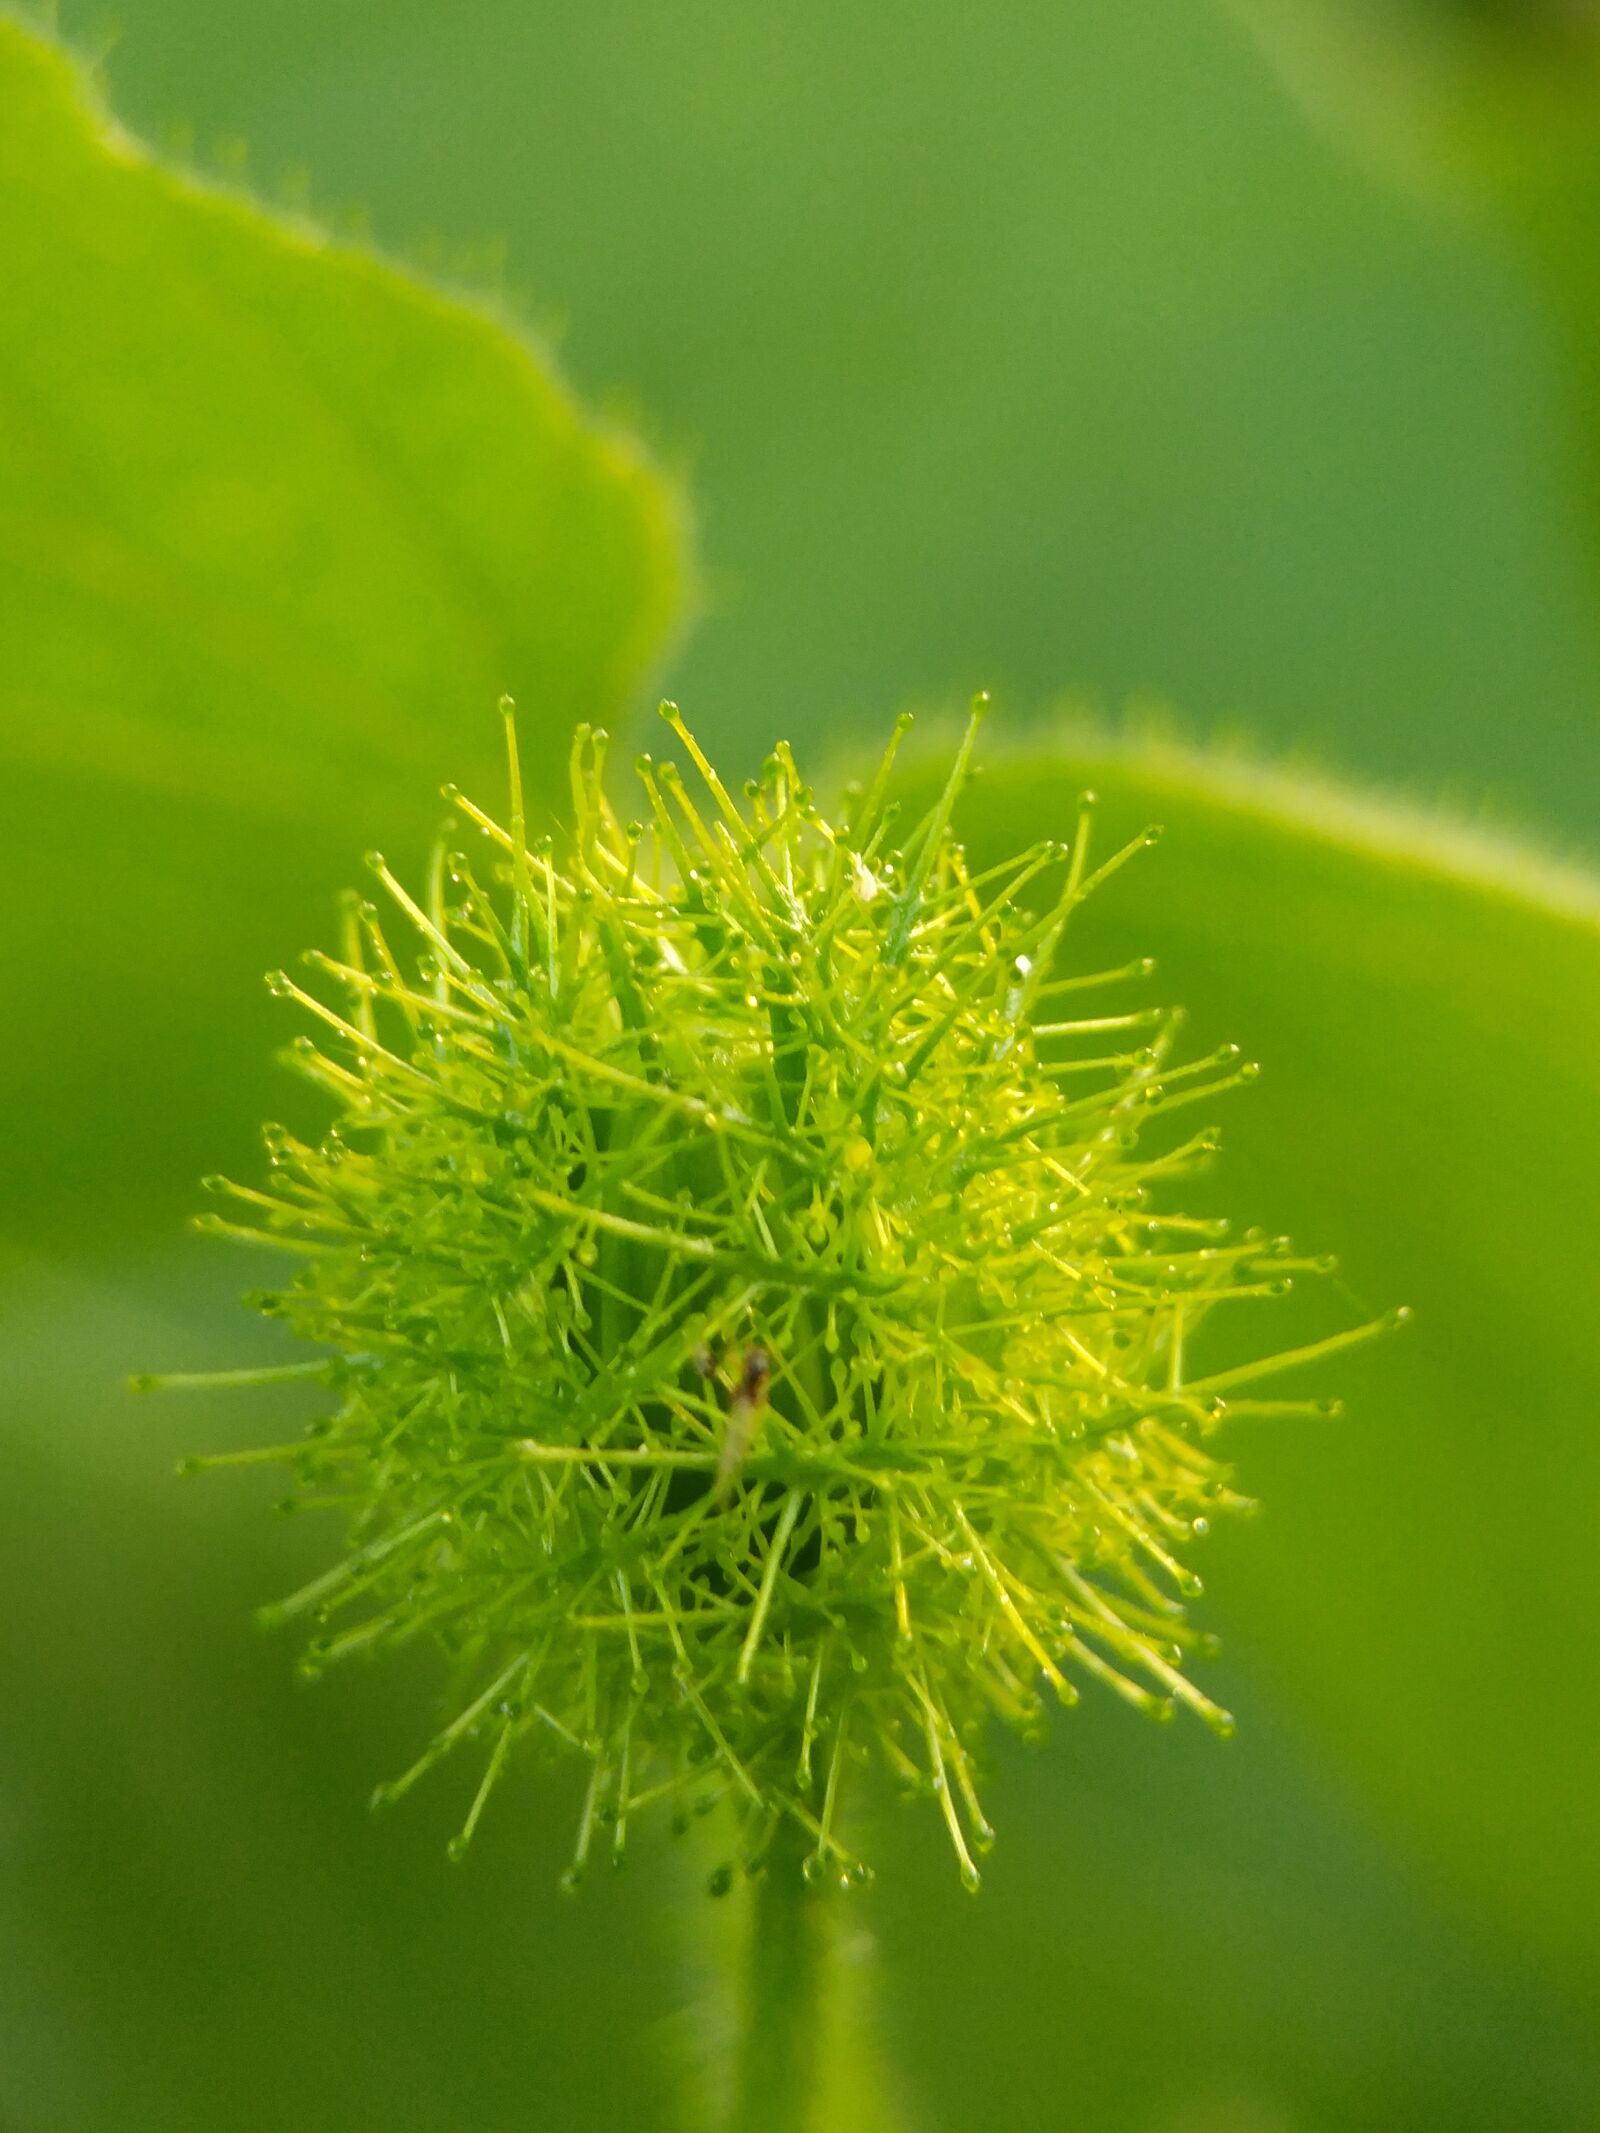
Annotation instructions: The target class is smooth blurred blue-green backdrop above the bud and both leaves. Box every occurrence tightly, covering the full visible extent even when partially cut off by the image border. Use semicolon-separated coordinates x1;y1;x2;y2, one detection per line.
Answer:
62;0;1600;834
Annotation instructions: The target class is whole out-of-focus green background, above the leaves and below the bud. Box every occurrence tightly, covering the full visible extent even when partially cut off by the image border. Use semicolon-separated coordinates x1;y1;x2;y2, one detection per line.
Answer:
0;12;1600;2133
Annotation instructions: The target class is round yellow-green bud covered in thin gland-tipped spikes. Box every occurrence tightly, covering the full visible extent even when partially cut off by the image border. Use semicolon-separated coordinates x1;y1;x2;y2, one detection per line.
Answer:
156;706;1399;1886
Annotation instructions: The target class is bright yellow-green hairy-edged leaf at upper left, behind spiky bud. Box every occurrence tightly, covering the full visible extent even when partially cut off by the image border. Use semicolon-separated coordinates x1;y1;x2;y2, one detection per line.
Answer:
0;17;685;1235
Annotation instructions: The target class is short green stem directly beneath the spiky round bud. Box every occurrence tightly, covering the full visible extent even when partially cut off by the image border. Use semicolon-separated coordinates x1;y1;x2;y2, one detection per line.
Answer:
730;1839;832;2133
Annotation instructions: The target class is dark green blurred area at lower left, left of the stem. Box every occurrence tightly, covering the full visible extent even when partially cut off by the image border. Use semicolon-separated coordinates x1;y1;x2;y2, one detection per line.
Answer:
0;1239;699;2133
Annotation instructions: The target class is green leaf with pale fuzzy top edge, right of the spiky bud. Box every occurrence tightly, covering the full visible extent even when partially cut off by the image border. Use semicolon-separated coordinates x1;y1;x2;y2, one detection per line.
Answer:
925;736;1600;1994
